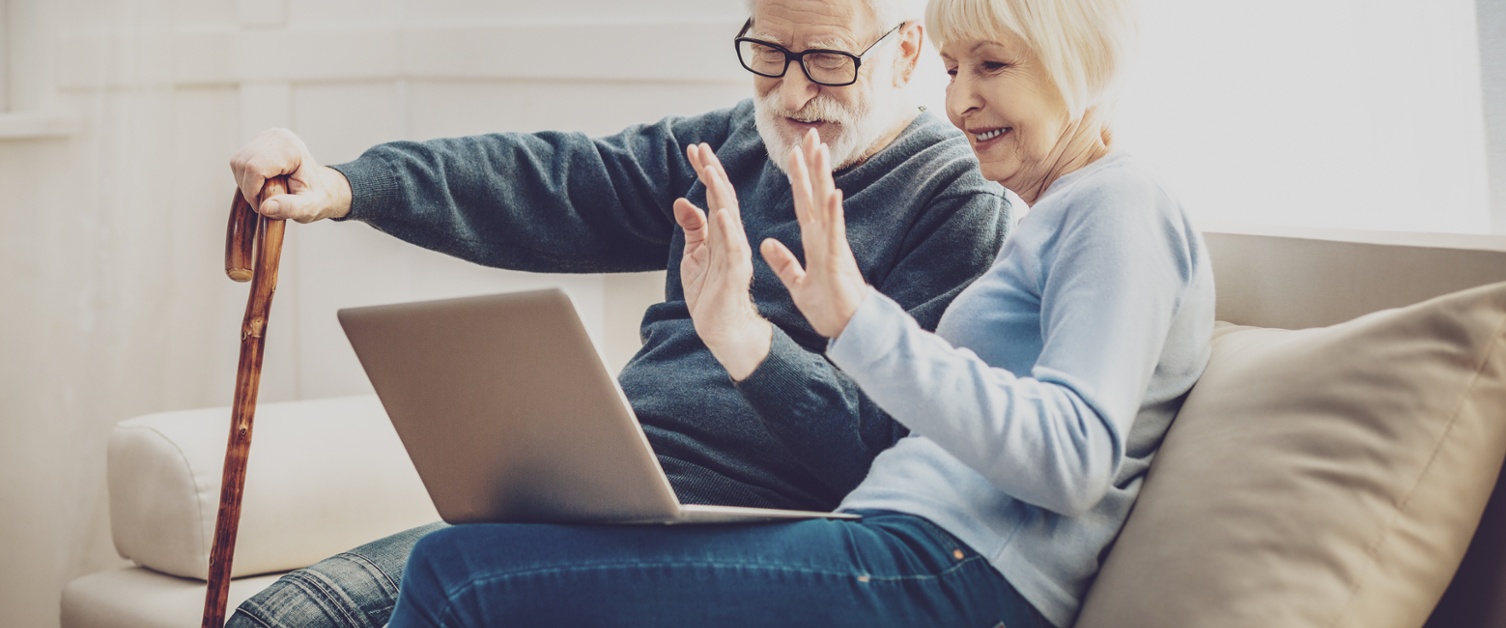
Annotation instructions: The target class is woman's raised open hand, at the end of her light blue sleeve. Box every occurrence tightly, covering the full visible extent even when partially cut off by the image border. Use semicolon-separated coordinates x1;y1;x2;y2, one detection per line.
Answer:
761;130;866;337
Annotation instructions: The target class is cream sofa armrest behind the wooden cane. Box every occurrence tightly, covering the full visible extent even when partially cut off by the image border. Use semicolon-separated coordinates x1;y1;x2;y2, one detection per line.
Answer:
107;396;438;580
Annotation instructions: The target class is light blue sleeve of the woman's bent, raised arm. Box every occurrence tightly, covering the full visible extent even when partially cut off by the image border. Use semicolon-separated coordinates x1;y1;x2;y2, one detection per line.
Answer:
828;179;1191;515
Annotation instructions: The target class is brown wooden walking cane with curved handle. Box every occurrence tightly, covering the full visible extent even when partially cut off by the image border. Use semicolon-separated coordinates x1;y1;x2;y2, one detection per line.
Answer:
202;176;288;628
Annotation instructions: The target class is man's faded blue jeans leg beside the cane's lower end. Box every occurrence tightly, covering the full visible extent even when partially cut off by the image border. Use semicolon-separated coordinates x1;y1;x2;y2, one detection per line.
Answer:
224;523;444;628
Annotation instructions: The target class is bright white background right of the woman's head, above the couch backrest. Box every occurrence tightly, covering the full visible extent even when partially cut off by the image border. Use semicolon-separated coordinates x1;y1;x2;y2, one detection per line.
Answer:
903;0;1506;233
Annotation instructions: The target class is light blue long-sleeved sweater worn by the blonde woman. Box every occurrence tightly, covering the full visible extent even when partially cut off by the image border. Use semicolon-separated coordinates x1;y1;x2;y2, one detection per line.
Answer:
827;154;1214;626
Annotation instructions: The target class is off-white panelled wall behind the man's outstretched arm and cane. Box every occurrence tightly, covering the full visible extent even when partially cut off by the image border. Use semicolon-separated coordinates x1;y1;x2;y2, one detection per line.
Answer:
0;0;748;626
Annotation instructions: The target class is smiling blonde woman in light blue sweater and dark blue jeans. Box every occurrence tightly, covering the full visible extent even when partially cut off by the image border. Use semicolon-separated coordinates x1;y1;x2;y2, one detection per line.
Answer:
393;0;1214;626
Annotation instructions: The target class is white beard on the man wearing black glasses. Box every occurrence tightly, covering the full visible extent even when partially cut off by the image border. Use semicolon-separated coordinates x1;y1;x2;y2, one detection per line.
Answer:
753;74;910;172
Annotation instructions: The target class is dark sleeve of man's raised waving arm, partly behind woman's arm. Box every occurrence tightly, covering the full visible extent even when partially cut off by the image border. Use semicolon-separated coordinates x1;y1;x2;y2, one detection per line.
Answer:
736;191;1011;494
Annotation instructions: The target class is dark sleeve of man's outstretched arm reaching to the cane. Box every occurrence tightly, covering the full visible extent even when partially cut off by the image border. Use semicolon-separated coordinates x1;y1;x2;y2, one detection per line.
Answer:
333;110;733;273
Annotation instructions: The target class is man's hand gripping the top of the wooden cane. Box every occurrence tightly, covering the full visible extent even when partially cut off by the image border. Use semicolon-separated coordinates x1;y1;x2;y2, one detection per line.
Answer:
230;128;351;223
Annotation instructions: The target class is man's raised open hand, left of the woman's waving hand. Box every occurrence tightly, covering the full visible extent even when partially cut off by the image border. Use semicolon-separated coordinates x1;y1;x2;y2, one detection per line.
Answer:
675;145;774;380
